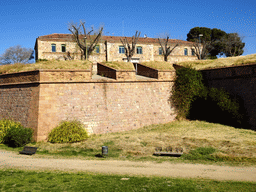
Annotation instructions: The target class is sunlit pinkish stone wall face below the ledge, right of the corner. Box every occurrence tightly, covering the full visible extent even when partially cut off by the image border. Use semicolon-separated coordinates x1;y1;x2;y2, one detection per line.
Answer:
37;81;175;140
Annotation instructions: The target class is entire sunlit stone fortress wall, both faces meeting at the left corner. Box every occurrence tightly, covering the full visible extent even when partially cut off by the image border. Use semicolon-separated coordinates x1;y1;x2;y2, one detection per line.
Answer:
0;65;176;141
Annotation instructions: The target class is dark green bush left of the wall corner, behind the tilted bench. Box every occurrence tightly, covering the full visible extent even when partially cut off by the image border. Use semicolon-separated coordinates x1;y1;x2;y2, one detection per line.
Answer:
3;123;33;147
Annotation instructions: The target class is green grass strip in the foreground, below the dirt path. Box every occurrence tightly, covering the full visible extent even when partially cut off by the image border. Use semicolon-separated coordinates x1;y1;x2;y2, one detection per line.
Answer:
0;169;256;192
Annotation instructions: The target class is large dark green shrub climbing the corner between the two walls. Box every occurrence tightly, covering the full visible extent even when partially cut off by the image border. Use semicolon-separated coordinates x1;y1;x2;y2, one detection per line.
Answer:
170;67;244;126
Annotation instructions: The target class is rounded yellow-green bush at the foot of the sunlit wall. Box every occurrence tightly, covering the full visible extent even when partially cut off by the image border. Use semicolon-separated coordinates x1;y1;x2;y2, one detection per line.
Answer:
48;121;88;143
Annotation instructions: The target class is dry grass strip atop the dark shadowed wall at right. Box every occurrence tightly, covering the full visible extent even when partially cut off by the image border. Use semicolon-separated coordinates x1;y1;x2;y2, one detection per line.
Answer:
177;54;256;70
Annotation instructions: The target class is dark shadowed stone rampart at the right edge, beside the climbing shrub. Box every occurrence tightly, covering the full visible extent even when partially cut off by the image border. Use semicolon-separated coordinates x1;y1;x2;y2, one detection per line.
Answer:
201;64;256;130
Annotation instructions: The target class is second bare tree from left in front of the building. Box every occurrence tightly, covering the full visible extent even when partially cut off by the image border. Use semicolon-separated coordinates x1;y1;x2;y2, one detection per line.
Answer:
120;31;140;62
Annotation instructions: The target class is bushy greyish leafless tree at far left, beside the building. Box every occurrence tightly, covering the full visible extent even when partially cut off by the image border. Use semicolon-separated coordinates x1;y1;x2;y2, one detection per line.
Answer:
0;45;34;64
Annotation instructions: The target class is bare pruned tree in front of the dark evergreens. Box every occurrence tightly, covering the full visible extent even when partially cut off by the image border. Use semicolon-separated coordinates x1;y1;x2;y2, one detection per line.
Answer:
192;40;214;60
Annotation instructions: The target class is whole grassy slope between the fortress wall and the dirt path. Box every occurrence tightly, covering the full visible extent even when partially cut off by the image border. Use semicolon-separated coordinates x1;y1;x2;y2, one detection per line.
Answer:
0;120;256;165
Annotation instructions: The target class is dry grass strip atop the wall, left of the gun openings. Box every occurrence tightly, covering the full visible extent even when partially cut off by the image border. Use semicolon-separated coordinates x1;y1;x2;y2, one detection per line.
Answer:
0;60;92;74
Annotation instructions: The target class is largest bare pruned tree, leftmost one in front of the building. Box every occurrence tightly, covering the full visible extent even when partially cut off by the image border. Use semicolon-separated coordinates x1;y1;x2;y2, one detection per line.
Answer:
68;21;103;59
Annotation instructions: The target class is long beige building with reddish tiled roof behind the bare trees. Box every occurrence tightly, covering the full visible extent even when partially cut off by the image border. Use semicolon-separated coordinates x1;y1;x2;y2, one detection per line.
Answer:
35;33;197;63
